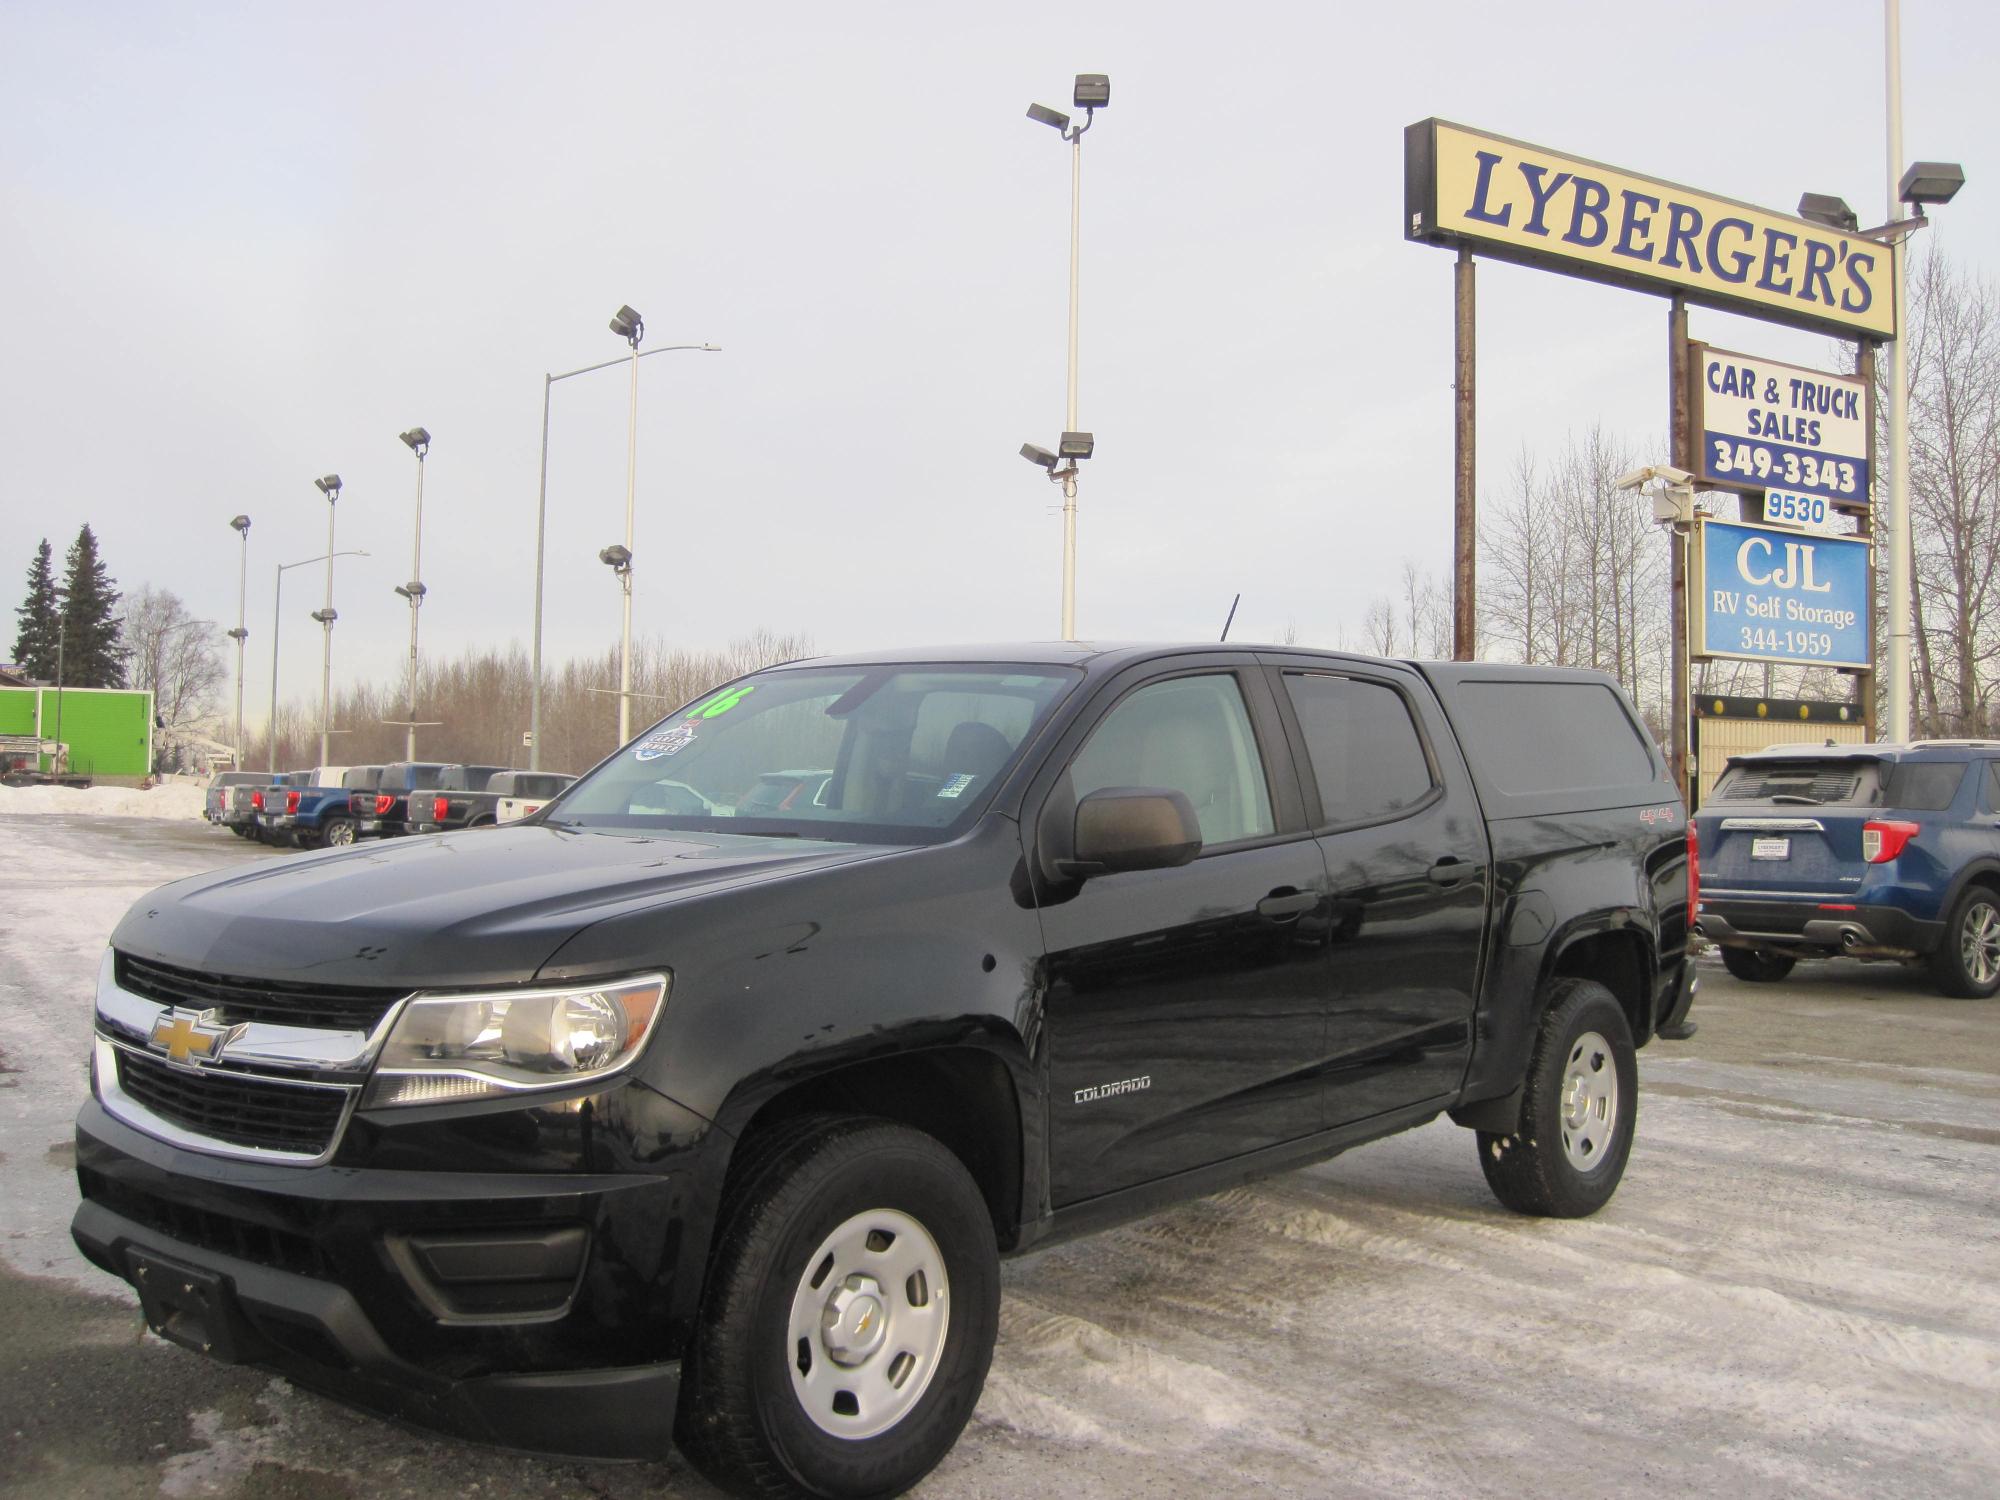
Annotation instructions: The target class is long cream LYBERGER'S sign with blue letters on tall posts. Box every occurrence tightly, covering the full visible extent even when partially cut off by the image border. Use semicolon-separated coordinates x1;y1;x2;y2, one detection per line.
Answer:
1402;120;1896;338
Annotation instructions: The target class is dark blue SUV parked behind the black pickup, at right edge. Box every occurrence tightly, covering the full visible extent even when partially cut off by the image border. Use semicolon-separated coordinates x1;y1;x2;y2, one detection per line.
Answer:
1692;740;2000;998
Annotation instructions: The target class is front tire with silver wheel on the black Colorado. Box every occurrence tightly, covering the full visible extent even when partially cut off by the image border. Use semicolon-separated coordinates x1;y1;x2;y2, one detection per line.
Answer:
674;1116;1000;1500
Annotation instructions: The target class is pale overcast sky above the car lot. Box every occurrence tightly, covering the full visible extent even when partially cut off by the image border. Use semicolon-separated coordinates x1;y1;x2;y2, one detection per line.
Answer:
0;0;2000;724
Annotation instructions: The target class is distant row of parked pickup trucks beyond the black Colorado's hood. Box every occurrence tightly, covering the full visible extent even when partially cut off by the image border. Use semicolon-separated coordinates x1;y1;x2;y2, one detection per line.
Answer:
202;762;576;848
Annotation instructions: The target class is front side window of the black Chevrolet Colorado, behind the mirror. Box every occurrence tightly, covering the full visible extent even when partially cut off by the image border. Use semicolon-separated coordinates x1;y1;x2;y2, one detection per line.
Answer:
1070;672;1274;848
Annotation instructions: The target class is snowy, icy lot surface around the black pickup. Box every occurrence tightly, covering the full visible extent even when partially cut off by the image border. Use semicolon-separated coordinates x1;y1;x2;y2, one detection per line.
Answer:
0;818;2000;1500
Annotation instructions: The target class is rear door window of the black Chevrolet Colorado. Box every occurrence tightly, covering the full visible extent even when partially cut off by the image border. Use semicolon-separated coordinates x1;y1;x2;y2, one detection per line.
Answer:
1284;672;1432;824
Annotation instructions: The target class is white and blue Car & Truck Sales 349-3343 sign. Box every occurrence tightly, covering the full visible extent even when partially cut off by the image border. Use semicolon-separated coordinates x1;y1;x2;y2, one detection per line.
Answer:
1694;344;1870;506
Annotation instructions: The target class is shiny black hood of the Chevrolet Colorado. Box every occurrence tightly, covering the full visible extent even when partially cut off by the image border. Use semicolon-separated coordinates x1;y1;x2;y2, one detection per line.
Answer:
112;824;896;988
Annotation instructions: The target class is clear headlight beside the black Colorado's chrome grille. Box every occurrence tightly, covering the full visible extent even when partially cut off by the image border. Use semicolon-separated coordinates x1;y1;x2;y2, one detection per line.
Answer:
362;974;670;1108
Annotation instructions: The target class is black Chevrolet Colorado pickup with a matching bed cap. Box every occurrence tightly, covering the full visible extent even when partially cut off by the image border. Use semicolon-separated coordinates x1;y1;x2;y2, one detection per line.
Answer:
72;644;1694;1496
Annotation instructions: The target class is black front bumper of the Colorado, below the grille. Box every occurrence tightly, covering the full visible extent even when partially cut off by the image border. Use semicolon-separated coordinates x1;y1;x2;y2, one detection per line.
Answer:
70;1102;686;1458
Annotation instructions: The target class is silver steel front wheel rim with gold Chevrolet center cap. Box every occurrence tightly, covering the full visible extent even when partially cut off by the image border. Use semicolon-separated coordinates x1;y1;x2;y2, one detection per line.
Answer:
786;1208;950;1438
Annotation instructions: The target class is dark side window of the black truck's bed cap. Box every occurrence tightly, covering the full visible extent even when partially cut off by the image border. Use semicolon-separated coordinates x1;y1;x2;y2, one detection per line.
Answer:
1452;682;1654;796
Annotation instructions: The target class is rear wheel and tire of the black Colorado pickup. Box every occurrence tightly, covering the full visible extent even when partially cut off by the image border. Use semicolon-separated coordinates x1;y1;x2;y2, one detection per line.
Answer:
1478;980;1638;1218
